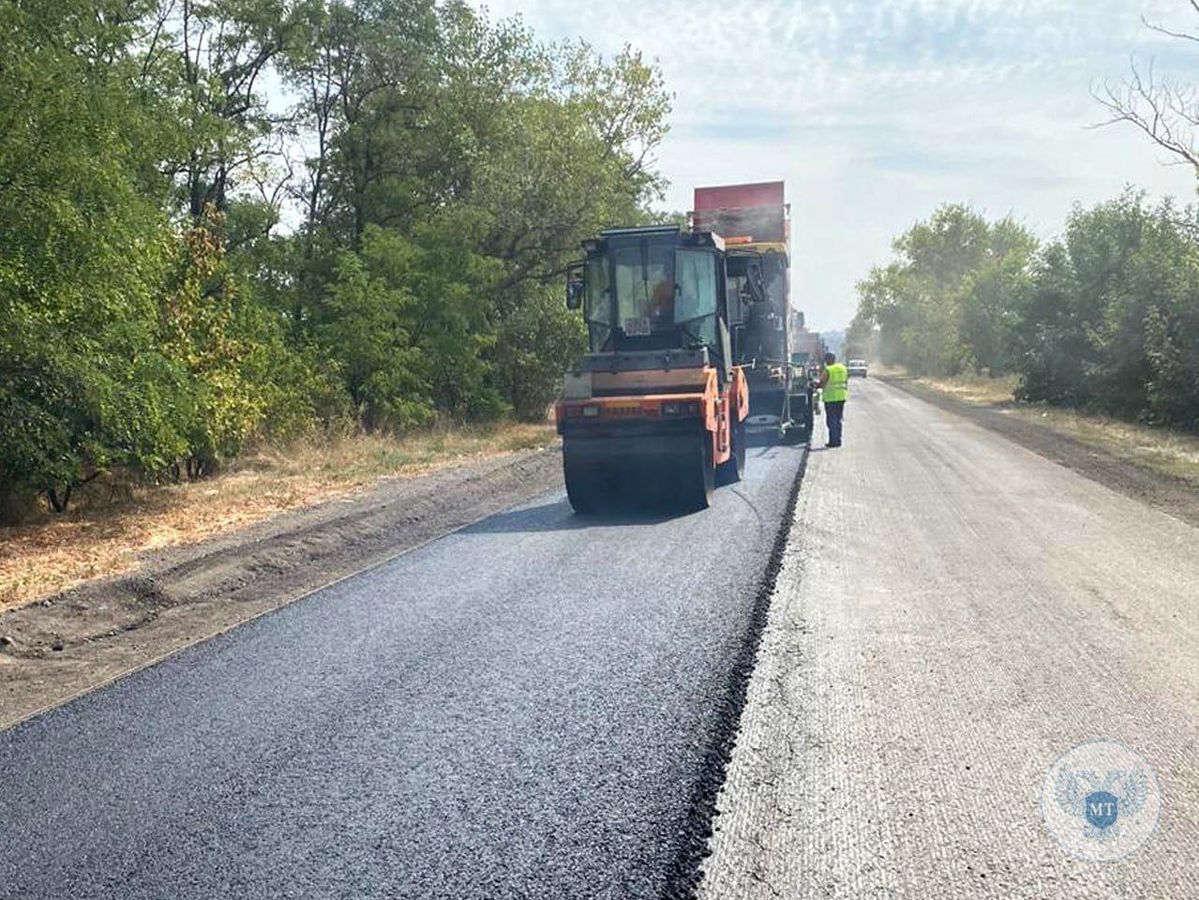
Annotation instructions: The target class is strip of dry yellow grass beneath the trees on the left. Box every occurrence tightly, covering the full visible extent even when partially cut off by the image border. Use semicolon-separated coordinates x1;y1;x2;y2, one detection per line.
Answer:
0;424;556;611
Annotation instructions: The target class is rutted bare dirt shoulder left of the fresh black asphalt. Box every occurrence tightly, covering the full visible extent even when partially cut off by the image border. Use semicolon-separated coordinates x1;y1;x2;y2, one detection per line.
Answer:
0;447;561;729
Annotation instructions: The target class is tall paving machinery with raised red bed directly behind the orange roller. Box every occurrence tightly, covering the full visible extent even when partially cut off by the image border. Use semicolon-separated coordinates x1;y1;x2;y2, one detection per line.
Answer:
691;181;813;442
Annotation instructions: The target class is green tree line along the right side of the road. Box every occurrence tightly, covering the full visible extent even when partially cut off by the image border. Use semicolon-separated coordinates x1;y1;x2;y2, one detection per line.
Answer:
850;191;1199;430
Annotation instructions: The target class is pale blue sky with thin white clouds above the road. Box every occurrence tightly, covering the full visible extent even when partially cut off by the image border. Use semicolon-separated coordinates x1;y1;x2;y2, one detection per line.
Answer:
477;0;1199;328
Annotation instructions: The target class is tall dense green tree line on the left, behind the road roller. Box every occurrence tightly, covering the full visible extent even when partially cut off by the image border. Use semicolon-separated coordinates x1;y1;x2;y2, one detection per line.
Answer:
0;0;670;509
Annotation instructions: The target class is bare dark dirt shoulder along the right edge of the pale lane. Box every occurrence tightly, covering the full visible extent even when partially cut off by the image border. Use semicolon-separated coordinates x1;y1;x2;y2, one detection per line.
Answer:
878;375;1199;526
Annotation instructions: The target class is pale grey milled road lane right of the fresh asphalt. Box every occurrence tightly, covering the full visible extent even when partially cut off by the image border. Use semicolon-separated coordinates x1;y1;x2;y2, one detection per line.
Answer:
700;380;1199;900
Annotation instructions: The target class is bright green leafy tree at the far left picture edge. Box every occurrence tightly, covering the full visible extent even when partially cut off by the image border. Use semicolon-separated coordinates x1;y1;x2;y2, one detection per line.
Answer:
0;0;185;509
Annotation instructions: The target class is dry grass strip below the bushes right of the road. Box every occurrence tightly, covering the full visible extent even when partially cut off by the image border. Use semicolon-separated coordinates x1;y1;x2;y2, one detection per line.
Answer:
916;375;1199;488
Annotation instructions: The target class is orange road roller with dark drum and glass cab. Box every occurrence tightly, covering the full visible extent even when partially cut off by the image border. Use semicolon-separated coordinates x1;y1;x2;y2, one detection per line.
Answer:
555;225;749;513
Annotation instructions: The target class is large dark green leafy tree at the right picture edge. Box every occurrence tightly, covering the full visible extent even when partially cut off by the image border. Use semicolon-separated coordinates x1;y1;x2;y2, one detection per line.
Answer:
1020;193;1199;428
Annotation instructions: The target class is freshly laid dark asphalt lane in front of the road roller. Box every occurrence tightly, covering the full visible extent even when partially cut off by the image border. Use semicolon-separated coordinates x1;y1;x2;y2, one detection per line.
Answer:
0;448;802;900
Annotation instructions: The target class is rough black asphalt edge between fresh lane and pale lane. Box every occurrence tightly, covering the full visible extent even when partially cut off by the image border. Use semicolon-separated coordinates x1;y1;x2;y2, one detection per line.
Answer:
661;445;812;900
